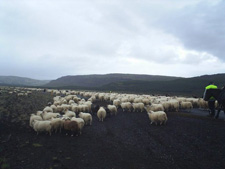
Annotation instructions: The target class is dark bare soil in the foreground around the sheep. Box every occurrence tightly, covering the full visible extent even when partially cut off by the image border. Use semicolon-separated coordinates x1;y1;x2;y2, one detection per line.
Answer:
0;92;225;169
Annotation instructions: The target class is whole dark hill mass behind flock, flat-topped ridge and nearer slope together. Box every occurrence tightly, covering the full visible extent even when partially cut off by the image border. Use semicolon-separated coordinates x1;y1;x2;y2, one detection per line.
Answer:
46;74;225;97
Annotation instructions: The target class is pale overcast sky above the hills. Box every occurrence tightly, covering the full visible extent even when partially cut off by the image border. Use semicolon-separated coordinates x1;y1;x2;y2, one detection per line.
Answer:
0;0;225;80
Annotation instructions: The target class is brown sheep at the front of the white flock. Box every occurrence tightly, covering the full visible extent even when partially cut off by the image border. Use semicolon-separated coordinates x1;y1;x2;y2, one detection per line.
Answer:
63;120;80;136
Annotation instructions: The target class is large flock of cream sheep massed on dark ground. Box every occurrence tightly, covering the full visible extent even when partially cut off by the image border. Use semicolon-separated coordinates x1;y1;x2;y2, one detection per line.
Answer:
26;89;211;136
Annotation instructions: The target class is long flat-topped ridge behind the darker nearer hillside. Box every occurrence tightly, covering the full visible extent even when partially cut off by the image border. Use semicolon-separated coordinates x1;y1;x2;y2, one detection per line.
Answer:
46;74;180;87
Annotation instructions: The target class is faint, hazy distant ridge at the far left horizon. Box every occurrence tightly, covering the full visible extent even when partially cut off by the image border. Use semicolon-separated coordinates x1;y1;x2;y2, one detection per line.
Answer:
0;76;50;86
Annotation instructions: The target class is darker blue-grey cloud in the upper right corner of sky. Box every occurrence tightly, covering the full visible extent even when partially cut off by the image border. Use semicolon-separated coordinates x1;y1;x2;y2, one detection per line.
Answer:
156;1;225;61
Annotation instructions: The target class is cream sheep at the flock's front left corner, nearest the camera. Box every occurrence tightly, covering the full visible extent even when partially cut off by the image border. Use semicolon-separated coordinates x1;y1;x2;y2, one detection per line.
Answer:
33;120;52;136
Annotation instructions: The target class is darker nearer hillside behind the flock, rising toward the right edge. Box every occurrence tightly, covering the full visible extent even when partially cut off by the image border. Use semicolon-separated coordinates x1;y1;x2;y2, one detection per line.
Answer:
101;74;225;97
